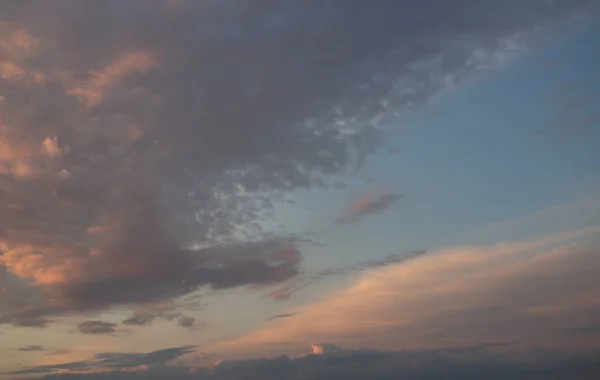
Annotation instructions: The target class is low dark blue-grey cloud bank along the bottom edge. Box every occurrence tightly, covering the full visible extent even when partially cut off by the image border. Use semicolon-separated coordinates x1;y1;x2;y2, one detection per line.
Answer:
12;345;600;380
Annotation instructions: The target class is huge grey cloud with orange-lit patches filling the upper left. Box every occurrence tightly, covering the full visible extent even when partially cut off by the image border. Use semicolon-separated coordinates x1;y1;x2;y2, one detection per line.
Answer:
0;0;598;326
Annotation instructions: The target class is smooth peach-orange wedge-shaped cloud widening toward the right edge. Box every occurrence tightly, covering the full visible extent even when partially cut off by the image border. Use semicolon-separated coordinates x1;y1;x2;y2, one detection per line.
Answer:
210;226;600;355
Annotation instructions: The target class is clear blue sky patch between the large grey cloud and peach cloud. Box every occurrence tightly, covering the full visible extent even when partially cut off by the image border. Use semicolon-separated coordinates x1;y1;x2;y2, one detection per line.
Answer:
294;20;600;274
